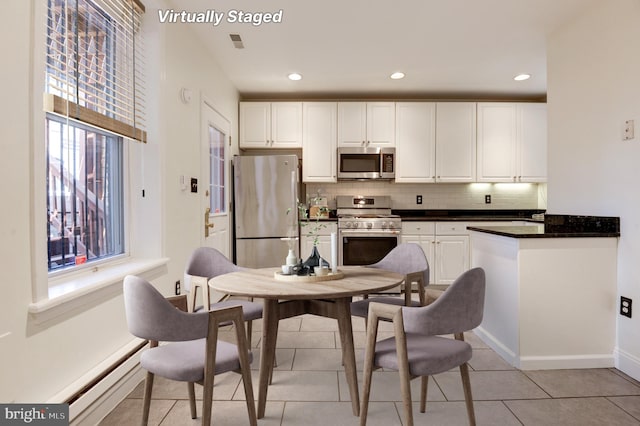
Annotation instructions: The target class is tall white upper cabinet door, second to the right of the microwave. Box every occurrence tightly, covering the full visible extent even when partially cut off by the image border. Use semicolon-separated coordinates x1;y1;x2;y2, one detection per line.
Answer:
436;102;476;182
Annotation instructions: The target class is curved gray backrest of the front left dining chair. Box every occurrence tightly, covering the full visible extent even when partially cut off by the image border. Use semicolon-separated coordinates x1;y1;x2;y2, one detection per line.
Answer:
123;275;209;342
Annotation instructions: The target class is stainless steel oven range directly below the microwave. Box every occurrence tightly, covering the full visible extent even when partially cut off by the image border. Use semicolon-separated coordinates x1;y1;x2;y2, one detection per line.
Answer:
336;195;402;265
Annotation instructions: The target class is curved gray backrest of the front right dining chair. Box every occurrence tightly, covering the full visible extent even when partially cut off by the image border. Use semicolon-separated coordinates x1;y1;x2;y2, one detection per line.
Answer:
402;268;485;335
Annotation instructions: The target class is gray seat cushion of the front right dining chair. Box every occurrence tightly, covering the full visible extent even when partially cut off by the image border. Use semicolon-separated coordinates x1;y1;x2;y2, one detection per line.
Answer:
373;333;472;376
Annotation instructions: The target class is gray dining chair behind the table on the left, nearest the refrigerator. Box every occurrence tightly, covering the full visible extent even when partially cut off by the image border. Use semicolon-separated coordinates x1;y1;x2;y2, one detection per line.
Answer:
184;247;262;346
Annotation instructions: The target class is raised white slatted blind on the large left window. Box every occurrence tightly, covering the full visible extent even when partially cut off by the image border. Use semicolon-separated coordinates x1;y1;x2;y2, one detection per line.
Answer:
44;0;147;142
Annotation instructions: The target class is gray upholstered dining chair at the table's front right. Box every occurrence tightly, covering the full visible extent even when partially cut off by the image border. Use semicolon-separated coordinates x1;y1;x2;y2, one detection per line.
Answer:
360;268;485;426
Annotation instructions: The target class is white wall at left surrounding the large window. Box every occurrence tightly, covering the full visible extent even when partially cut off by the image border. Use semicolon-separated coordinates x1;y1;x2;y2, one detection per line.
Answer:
0;0;238;408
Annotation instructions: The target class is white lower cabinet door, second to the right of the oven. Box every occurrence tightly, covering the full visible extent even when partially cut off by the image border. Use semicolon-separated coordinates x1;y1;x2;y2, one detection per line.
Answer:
435;235;469;284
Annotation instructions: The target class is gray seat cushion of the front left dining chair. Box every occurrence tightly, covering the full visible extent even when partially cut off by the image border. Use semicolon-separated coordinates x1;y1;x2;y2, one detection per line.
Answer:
140;339;253;382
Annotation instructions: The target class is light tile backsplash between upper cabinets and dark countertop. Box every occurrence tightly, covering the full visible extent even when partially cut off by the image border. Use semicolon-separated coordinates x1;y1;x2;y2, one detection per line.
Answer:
306;181;547;210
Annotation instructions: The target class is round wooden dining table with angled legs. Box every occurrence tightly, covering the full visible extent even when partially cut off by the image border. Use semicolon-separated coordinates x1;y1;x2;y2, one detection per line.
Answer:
209;266;405;418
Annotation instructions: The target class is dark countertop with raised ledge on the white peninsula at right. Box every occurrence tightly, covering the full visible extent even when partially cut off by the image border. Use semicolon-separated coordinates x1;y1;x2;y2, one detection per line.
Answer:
467;215;620;238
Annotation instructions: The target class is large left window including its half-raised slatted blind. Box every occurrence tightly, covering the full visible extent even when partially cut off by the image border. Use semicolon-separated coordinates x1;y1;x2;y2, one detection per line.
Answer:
44;0;146;272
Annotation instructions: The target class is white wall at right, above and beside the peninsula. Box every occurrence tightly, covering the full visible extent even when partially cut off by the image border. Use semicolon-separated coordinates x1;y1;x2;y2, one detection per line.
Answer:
547;0;640;379
